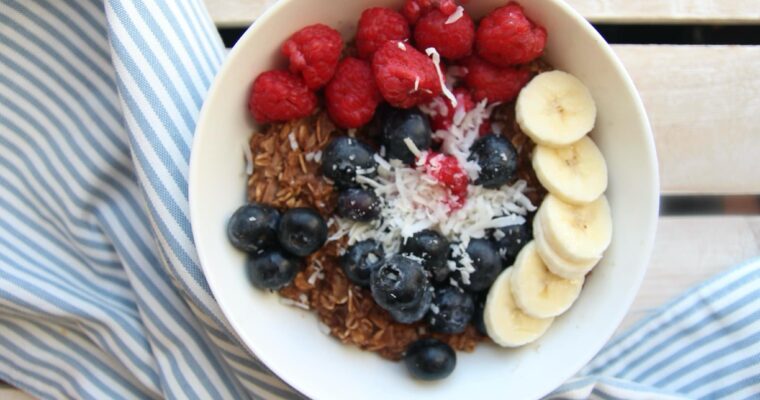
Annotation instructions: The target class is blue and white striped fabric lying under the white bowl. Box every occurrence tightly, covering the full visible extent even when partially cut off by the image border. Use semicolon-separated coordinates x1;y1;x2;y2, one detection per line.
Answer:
0;0;760;399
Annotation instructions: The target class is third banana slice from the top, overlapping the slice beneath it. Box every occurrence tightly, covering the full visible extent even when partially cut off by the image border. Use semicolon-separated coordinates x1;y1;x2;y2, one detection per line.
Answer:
540;194;612;263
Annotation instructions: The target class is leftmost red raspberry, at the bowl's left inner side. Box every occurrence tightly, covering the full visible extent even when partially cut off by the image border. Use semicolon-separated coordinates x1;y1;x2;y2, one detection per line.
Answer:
248;71;317;124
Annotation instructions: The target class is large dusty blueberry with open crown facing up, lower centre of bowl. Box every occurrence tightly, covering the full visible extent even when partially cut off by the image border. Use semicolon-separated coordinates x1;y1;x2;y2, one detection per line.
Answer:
370;254;430;311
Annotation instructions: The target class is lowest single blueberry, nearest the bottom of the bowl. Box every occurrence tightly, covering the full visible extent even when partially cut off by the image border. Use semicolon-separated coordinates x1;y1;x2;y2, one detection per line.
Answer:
404;339;457;381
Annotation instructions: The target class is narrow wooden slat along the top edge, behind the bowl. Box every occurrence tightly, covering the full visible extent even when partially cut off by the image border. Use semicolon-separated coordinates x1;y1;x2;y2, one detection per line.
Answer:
205;0;760;26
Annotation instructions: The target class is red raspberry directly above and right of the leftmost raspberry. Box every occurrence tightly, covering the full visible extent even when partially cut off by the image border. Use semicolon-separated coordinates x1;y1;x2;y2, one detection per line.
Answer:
282;24;343;90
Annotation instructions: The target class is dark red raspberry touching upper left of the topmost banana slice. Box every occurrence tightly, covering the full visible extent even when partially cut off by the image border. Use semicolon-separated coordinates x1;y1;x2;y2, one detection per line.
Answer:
463;56;531;103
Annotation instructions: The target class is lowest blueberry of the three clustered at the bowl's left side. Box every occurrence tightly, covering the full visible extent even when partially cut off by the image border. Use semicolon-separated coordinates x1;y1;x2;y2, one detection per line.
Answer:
247;249;303;290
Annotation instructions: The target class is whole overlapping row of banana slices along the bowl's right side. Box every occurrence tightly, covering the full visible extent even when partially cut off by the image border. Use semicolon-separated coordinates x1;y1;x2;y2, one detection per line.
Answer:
484;71;612;347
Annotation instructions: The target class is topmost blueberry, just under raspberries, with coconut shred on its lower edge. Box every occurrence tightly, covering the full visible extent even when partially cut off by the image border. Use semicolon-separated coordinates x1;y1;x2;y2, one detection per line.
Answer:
382;108;433;165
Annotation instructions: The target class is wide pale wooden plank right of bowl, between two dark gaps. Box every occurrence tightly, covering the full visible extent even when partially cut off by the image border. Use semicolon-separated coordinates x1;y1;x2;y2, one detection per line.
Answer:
613;45;760;194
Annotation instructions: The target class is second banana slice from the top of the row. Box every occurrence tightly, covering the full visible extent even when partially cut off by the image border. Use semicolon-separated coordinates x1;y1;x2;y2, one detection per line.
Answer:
533;136;607;204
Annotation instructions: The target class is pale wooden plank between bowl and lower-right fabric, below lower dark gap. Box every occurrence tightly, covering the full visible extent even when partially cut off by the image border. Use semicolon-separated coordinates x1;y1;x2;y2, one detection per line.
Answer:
618;216;760;331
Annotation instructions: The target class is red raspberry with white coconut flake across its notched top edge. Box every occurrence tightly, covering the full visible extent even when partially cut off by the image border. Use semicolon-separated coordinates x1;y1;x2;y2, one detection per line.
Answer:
414;10;475;60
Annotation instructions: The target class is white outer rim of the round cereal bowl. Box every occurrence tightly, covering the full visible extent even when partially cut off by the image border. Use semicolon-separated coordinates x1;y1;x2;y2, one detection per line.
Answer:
188;0;660;398
